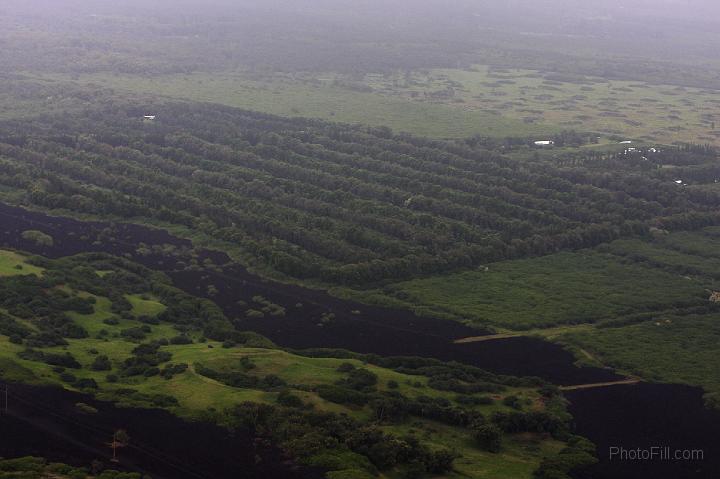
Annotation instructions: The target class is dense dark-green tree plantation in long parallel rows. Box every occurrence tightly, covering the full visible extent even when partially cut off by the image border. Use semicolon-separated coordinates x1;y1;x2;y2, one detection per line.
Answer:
0;99;717;284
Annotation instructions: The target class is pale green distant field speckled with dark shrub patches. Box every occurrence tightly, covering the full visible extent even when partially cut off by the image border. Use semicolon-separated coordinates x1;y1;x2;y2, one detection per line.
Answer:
363;66;720;144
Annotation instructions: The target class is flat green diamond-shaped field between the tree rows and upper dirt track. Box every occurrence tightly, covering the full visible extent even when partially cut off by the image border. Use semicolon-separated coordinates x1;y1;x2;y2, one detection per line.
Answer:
389;251;707;330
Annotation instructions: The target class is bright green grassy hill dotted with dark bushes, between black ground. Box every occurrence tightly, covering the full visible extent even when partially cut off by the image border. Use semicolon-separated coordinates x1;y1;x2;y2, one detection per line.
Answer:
0;249;569;478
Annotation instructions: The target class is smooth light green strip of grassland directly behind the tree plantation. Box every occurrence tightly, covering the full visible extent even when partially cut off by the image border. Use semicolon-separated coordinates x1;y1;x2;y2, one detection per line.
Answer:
45;73;559;138
